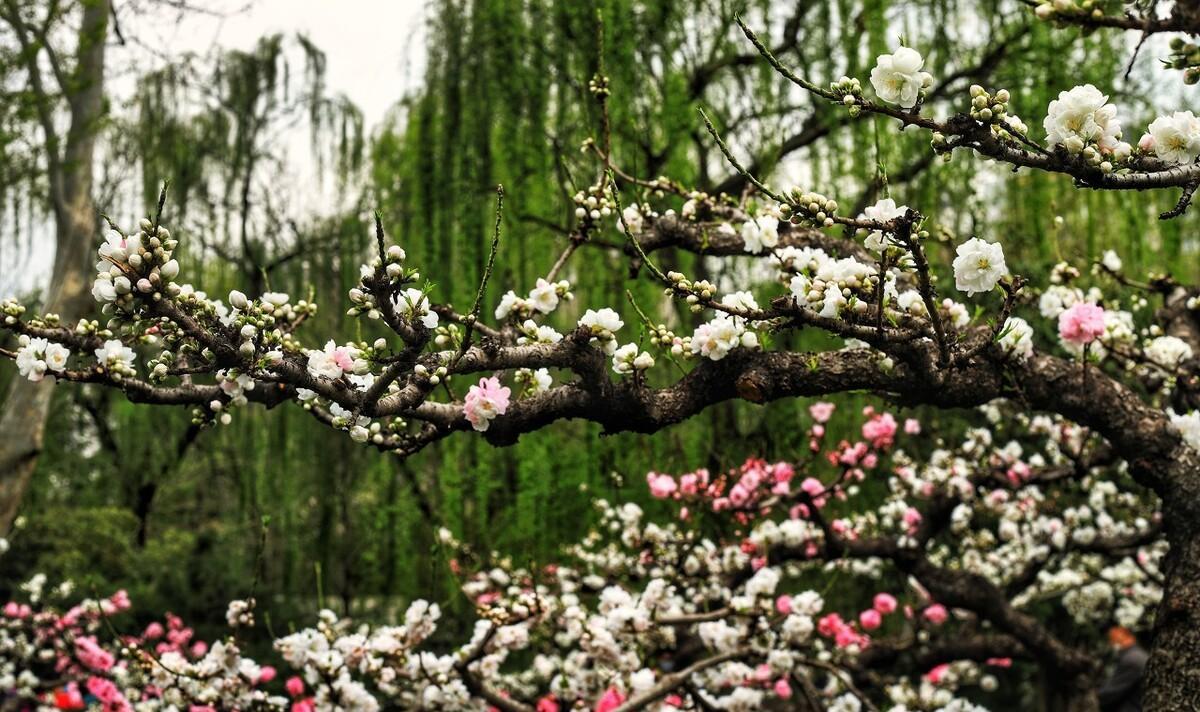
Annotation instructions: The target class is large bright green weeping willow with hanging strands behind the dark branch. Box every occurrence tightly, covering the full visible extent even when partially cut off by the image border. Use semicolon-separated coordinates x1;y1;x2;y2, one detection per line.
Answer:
372;0;1089;566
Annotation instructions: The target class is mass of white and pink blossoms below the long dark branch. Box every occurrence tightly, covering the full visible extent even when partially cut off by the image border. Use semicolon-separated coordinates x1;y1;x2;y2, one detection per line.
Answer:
0;402;1165;712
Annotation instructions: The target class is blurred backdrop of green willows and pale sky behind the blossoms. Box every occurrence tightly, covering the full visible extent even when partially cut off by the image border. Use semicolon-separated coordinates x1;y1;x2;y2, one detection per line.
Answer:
0;0;1200;691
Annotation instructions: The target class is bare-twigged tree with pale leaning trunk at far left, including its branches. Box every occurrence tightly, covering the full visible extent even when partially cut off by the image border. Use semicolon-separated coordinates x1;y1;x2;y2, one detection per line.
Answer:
0;0;110;531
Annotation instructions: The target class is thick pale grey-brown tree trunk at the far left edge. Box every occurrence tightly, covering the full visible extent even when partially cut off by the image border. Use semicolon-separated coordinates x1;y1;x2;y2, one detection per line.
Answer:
0;0;110;536
